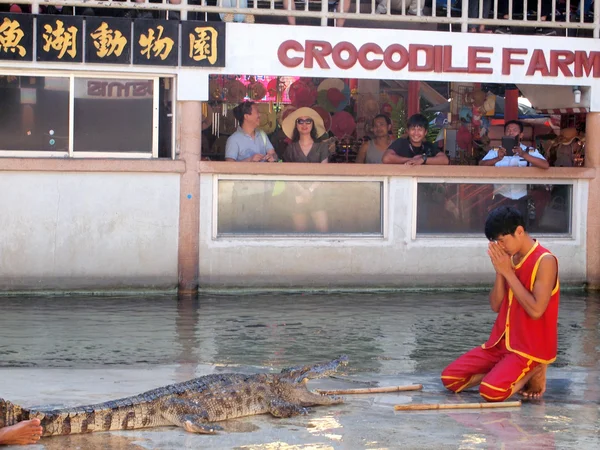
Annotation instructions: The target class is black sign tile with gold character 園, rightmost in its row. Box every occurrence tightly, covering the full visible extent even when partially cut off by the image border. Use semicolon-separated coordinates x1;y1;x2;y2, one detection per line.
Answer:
181;21;225;67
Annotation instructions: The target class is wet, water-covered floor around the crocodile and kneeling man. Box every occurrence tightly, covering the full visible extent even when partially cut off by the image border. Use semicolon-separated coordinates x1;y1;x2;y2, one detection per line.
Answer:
0;292;600;450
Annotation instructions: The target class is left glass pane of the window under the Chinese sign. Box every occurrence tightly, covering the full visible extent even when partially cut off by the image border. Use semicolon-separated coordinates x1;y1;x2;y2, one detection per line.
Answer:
0;75;69;152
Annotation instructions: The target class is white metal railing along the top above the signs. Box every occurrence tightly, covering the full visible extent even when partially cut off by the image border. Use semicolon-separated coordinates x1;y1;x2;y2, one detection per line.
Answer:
0;0;600;38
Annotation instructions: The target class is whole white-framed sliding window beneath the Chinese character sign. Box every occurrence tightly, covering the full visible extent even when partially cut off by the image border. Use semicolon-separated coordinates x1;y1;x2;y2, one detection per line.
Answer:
0;75;174;158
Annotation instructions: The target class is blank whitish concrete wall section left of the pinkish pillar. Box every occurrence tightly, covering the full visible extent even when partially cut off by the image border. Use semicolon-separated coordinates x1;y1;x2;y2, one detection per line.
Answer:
0;171;180;291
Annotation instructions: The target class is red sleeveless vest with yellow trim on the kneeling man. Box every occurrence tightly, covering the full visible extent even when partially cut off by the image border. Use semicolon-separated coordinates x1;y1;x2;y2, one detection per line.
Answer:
482;241;560;364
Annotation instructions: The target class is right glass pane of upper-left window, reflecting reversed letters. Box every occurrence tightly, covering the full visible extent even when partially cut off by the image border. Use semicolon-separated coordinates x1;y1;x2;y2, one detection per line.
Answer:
73;78;154;153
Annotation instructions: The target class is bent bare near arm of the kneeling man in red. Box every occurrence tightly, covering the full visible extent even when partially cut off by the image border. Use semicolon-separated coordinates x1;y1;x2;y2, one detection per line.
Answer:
506;255;558;319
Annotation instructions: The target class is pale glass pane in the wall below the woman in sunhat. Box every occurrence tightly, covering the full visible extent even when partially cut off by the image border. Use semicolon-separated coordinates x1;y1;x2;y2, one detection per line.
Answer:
217;180;383;236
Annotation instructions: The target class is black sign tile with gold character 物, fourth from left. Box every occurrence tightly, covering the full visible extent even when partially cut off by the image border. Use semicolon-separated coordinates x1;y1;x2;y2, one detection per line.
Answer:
133;19;179;66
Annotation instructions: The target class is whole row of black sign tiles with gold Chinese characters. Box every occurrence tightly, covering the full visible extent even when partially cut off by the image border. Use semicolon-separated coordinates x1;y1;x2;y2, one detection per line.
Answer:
0;13;225;67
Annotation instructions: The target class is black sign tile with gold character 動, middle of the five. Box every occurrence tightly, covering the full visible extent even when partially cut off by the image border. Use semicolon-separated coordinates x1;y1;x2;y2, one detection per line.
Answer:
85;17;132;64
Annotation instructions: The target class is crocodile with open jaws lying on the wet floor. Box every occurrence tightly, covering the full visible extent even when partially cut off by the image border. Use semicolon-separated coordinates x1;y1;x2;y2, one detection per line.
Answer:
0;355;348;437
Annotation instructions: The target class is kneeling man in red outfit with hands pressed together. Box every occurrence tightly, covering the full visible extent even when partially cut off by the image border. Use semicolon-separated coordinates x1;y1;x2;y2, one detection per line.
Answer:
442;206;560;402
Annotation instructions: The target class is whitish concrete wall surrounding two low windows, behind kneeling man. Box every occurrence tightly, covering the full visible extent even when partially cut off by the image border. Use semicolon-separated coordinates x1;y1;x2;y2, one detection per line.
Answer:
199;174;588;287
